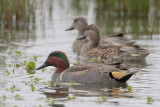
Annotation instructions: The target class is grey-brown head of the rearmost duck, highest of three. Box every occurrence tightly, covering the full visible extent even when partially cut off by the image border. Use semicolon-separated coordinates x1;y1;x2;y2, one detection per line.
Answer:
66;17;88;35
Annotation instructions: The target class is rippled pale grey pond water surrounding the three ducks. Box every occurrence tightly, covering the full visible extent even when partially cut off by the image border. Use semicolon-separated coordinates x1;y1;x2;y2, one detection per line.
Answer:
0;0;160;107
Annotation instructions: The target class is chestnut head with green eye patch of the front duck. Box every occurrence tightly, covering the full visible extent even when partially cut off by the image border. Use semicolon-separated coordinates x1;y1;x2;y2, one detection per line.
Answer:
36;51;69;73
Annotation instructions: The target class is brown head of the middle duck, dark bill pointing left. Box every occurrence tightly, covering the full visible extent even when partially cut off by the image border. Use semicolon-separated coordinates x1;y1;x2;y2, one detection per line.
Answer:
77;24;101;48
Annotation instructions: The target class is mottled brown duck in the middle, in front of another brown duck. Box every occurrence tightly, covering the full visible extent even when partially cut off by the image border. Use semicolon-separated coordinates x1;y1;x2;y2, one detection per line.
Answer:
77;24;149;61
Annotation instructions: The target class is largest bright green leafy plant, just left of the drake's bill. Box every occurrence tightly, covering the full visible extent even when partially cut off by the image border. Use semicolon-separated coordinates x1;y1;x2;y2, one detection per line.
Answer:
26;61;36;74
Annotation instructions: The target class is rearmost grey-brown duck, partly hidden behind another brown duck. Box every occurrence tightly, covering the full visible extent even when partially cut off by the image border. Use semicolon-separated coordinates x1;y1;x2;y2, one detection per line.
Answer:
66;17;134;55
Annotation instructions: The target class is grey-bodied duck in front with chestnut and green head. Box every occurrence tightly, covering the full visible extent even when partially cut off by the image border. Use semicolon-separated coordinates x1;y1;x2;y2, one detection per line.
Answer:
37;51;134;84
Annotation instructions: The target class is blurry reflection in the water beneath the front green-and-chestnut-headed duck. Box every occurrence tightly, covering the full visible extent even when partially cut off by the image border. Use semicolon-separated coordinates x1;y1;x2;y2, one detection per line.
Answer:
44;83;131;101
